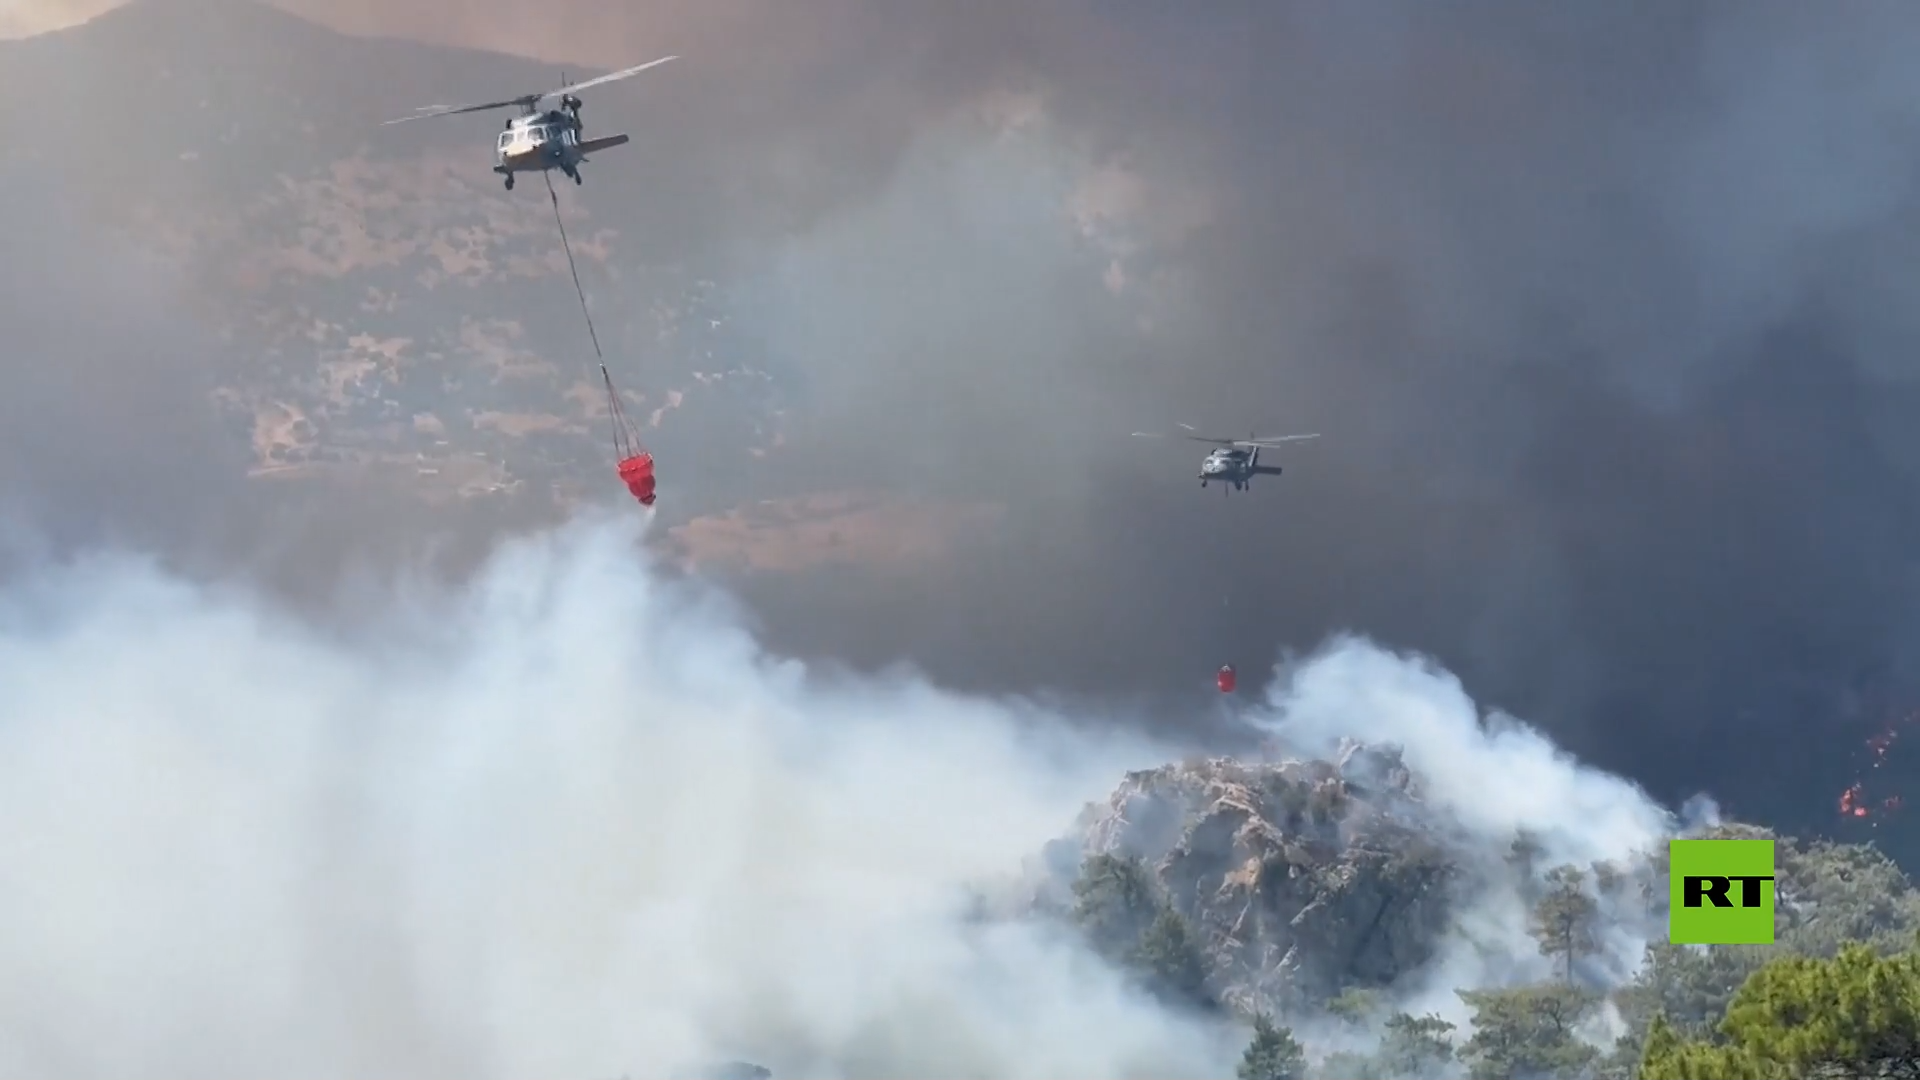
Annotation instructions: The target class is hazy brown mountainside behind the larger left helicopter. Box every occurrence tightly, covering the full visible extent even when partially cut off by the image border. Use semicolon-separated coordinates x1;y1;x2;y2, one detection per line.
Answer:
0;0;778;502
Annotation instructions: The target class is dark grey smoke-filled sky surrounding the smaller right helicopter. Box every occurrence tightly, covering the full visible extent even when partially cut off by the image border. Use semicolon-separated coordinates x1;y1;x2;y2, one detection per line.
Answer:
11;0;1920;849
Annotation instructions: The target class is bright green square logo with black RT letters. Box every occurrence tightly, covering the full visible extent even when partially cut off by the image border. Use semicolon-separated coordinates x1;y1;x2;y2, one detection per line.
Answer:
1667;840;1774;945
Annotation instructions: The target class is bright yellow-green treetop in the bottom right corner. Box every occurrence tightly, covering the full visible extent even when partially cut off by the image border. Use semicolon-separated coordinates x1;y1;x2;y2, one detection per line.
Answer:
1640;944;1920;1080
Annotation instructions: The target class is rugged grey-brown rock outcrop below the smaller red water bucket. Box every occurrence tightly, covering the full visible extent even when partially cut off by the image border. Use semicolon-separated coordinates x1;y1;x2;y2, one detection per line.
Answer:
1048;744;1457;1007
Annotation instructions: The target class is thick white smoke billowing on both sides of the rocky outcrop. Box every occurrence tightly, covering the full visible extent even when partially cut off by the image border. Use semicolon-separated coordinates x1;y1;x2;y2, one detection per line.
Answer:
0;515;1689;1080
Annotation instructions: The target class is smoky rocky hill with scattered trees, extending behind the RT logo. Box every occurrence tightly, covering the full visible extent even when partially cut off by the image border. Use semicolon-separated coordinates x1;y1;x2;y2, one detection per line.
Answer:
1035;744;1920;1080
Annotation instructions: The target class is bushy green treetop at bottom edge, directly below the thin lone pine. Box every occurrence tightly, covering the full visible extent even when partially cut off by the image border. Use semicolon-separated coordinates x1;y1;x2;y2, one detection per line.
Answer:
1457;982;1599;1080
